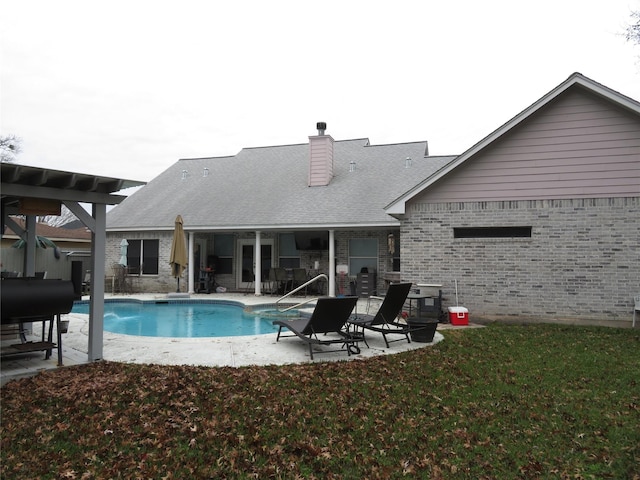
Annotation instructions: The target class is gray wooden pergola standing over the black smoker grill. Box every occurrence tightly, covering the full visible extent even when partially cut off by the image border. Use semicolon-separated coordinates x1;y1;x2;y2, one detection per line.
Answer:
0;163;145;362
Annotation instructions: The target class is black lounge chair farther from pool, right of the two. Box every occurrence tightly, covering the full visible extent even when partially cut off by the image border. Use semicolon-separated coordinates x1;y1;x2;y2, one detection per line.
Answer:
349;283;411;348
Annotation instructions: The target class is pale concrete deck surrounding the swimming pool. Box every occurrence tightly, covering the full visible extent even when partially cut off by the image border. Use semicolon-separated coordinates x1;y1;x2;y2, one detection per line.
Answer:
0;293;476;385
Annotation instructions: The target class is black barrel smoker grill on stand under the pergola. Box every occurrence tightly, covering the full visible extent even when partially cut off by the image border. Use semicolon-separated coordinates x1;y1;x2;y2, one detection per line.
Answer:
0;277;75;366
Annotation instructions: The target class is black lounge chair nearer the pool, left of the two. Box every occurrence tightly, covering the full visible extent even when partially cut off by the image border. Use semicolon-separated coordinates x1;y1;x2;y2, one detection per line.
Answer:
273;297;362;360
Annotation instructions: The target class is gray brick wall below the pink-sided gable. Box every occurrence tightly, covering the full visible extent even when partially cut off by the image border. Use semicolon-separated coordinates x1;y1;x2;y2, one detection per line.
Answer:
401;197;640;326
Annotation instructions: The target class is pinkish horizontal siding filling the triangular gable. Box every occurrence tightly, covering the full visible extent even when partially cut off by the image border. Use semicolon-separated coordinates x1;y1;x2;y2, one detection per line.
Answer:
420;89;640;202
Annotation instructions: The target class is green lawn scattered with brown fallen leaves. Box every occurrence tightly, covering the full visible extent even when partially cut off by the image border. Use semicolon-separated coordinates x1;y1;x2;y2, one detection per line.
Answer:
0;325;640;479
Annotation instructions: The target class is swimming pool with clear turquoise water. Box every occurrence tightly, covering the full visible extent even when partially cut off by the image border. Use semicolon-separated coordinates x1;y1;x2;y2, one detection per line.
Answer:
71;300;299;338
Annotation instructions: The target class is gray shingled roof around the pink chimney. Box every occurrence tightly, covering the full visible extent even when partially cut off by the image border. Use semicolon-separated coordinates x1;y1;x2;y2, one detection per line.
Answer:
107;139;454;231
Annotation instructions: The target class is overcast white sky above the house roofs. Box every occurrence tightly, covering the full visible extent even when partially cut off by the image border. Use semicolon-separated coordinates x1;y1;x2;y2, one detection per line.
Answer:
0;0;640;186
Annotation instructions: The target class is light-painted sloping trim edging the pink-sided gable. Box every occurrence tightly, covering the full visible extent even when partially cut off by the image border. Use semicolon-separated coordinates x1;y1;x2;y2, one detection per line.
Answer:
385;73;640;215
